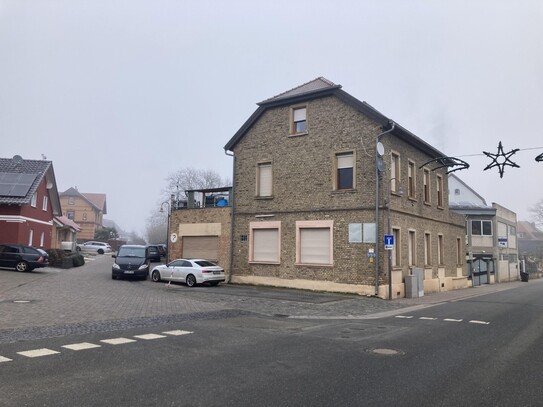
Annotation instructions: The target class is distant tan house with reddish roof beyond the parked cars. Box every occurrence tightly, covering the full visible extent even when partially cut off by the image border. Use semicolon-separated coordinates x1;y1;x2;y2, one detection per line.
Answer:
60;188;107;241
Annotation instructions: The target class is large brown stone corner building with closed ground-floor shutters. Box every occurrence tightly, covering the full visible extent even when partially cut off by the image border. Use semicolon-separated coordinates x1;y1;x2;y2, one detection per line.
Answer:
224;78;467;298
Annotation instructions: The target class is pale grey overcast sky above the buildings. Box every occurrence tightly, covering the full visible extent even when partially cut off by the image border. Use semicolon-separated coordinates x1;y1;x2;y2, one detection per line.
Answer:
0;0;543;234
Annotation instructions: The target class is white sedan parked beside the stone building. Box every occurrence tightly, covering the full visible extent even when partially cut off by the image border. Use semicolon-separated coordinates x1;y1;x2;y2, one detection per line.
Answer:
151;259;224;287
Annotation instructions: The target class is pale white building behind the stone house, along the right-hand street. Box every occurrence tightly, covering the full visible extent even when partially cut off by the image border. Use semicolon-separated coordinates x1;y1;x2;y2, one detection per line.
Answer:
449;174;519;285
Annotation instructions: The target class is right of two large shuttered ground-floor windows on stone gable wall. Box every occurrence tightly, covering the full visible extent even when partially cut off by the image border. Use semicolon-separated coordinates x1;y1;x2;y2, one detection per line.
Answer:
296;220;334;266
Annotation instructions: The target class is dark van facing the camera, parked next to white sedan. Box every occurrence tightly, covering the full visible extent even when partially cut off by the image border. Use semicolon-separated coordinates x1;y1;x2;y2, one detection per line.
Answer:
111;244;151;280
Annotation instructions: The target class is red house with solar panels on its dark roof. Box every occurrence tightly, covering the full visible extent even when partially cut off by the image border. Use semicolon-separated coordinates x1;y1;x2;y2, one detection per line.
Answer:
0;155;61;249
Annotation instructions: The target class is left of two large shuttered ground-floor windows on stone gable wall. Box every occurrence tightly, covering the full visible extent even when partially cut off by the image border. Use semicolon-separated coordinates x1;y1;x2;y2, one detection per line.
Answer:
249;221;281;264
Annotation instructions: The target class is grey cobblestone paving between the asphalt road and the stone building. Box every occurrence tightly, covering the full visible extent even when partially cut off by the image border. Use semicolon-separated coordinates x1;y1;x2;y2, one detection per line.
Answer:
0;255;523;343
